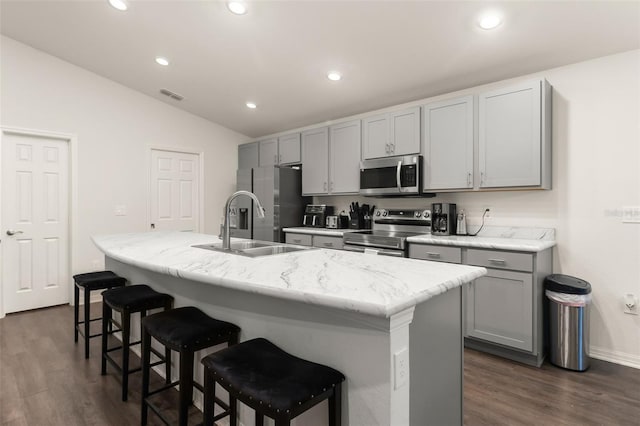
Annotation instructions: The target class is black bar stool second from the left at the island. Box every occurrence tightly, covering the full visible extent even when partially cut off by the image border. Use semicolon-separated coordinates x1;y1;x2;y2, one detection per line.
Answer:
101;284;173;401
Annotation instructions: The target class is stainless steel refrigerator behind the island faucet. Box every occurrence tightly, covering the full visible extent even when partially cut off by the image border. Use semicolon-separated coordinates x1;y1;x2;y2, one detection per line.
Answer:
229;166;311;242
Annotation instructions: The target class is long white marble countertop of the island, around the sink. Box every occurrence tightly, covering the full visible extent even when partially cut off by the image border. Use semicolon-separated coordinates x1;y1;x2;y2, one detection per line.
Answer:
93;232;487;317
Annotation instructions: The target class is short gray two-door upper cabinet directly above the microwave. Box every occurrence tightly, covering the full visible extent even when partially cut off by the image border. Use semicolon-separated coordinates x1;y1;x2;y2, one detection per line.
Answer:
362;107;420;159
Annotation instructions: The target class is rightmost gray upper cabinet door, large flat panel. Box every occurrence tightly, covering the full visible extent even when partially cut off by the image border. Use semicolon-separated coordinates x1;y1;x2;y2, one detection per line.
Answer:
478;80;542;188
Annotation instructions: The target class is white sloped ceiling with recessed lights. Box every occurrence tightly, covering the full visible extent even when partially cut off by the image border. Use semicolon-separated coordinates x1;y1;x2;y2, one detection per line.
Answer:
0;0;640;137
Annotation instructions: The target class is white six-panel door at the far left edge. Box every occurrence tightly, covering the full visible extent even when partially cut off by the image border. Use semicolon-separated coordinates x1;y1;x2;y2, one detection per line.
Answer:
1;132;70;313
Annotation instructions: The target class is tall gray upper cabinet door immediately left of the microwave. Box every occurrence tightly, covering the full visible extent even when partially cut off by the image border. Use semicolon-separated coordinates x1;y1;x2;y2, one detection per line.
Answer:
329;120;361;194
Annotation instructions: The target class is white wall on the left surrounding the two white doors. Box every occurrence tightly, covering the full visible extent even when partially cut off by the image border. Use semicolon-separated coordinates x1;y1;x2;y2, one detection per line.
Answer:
0;37;248;302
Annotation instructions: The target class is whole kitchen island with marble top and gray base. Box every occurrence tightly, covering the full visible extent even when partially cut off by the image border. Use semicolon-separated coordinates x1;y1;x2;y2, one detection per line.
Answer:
94;232;486;426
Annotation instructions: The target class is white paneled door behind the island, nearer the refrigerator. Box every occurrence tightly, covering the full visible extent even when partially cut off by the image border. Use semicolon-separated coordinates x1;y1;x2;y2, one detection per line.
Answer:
150;149;200;231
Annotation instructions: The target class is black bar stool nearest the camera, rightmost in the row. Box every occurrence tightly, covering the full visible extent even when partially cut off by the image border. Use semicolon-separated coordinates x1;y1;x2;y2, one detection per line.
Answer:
202;339;344;426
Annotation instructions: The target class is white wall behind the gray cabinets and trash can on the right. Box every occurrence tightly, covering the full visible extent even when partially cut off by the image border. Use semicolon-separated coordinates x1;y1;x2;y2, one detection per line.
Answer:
315;50;640;368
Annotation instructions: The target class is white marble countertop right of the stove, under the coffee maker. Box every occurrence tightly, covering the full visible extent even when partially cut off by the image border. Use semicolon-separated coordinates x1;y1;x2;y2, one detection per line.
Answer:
407;226;556;252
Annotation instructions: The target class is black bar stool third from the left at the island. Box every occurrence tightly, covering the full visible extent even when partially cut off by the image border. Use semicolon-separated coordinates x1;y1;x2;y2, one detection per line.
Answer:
141;307;240;426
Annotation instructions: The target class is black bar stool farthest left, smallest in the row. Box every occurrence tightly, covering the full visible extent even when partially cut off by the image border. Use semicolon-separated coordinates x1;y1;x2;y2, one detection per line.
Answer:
73;271;127;358
